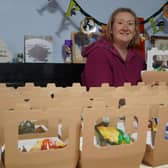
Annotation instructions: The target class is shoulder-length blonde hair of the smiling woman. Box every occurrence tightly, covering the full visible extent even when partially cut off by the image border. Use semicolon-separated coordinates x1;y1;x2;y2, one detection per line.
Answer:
106;8;140;48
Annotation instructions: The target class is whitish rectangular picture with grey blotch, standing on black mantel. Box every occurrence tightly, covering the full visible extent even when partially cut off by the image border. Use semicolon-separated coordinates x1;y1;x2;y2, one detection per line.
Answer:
24;35;53;63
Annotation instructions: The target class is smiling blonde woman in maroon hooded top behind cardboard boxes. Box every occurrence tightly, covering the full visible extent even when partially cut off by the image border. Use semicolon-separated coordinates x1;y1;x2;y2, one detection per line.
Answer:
82;8;146;88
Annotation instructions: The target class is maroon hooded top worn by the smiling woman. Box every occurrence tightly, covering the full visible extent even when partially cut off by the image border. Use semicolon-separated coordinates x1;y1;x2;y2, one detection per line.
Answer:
81;38;146;88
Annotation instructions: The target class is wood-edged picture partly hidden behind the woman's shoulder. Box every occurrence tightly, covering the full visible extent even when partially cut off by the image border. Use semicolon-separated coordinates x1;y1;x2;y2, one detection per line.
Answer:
71;32;100;63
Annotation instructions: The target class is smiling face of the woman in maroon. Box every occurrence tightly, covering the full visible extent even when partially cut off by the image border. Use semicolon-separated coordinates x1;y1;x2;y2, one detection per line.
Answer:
111;12;136;46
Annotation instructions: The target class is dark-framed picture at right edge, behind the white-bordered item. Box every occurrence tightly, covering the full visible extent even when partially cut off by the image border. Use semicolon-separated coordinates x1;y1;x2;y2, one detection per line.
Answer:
151;36;168;50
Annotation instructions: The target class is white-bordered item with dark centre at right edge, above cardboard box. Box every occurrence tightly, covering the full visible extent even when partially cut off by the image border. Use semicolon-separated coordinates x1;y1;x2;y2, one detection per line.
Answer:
147;48;168;71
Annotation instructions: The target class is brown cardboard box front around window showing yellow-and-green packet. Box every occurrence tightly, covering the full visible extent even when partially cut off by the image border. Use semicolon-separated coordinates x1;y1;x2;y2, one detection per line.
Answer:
80;103;148;168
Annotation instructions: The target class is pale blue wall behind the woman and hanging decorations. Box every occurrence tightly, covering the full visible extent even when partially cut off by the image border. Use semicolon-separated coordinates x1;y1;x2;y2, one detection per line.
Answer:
0;0;167;63
